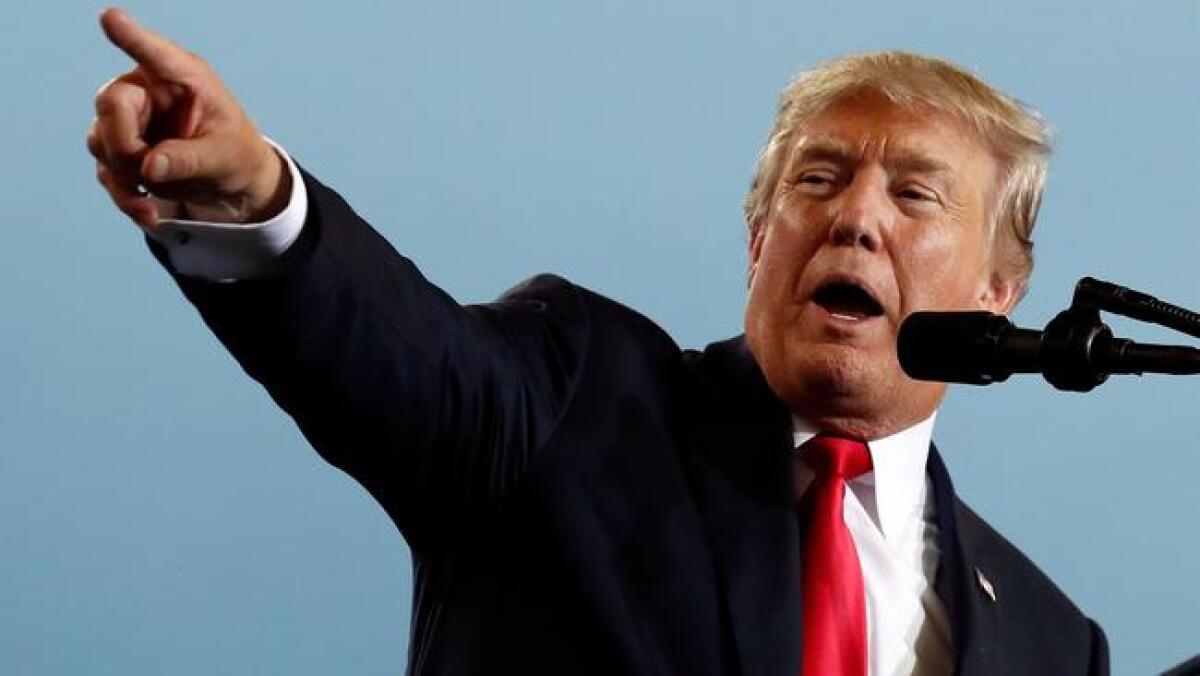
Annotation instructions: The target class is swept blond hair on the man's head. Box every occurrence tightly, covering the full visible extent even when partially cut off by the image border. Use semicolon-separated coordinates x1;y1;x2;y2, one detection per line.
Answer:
745;52;1050;287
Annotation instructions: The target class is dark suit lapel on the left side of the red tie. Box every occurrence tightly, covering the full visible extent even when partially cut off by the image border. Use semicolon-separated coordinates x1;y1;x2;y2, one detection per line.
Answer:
690;339;802;676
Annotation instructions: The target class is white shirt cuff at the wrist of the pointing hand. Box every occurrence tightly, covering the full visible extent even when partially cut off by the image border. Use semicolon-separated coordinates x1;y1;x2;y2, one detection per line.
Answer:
144;138;308;282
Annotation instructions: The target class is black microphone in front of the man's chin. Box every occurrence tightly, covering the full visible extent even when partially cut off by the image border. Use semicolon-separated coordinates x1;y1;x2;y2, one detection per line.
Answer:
896;309;1200;391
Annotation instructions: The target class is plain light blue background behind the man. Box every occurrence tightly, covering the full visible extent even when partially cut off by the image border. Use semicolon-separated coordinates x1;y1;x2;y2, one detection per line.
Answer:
0;0;1200;675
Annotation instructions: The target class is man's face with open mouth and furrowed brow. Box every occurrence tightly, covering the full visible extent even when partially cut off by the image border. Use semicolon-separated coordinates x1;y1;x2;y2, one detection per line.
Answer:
746;92;1016;439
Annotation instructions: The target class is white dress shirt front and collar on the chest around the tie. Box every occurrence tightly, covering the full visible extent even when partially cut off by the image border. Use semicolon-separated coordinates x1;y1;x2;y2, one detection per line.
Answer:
793;414;954;676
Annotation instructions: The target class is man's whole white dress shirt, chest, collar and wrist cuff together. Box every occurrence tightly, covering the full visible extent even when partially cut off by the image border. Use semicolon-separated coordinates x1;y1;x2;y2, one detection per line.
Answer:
146;139;954;676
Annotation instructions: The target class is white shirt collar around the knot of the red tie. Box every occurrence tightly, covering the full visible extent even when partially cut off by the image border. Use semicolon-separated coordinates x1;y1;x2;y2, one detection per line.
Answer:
792;411;937;540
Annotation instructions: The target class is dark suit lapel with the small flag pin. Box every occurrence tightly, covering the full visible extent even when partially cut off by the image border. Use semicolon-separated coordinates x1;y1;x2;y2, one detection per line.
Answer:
926;445;1012;676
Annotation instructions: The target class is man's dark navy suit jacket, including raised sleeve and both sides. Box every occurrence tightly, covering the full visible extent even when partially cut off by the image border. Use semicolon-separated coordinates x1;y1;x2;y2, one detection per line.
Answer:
151;169;1108;676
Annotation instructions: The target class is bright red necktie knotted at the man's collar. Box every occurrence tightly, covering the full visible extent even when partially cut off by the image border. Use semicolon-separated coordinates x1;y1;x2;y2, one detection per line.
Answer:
800;435;871;676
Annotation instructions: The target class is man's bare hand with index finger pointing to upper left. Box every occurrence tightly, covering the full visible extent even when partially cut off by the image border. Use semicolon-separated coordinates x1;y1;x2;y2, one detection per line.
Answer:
88;8;292;228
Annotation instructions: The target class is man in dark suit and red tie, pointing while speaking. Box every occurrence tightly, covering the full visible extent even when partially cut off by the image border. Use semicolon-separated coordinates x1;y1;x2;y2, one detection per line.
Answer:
88;6;1108;675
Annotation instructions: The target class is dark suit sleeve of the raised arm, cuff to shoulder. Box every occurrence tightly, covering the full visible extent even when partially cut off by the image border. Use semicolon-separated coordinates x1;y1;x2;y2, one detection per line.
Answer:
146;166;589;544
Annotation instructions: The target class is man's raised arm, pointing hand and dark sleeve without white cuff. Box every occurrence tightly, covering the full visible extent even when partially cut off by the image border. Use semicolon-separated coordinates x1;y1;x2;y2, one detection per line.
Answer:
89;11;590;546
